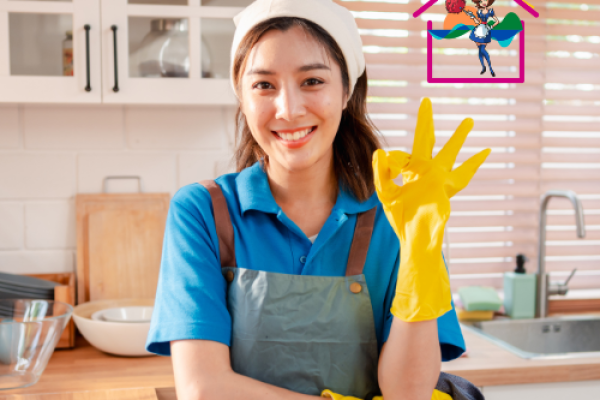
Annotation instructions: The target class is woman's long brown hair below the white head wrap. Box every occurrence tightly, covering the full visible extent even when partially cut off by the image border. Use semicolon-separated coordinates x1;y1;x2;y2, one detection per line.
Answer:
233;17;381;201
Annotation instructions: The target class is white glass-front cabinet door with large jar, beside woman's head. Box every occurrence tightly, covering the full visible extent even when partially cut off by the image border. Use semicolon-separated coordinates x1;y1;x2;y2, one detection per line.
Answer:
101;0;246;104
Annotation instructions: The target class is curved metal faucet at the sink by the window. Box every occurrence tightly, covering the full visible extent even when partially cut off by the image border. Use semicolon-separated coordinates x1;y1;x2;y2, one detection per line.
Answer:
536;190;585;318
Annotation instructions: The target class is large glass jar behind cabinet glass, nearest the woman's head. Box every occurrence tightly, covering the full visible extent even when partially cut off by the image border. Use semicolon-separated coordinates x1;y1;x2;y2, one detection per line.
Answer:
138;18;190;78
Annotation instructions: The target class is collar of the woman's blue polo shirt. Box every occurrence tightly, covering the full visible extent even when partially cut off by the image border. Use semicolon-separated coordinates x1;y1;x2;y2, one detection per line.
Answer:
235;161;378;215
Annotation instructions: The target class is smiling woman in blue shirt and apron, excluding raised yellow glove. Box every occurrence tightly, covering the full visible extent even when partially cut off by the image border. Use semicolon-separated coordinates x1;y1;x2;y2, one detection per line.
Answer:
147;0;490;400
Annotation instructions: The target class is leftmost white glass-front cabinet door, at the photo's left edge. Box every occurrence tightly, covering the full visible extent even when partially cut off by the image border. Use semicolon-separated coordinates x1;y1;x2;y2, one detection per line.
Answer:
0;0;102;103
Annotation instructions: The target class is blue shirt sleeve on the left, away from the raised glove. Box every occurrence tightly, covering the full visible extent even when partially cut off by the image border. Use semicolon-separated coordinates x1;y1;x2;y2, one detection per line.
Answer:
146;184;231;356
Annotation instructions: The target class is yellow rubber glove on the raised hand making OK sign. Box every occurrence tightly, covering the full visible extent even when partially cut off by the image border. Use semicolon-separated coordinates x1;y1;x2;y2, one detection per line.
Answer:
373;98;491;322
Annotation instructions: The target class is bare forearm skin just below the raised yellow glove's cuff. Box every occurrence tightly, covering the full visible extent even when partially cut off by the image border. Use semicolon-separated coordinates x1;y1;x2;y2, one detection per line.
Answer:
378;317;441;400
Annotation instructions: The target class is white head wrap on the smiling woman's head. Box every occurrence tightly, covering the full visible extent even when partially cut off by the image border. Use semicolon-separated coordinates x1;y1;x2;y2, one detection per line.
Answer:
230;0;365;97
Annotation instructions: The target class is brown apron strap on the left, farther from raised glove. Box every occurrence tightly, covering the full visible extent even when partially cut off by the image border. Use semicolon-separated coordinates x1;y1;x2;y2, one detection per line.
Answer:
199;180;236;267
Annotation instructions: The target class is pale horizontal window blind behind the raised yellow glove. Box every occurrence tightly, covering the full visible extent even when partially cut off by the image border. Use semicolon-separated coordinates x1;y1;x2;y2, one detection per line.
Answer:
336;0;600;289
